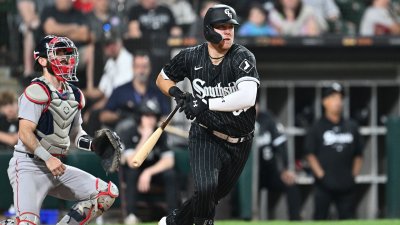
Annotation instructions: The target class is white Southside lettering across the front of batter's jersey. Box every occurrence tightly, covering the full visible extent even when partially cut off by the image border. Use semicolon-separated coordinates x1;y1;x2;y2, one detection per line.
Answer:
193;78;238;98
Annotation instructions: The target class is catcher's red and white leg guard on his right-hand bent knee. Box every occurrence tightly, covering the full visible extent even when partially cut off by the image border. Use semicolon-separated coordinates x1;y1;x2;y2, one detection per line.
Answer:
57;179;118;225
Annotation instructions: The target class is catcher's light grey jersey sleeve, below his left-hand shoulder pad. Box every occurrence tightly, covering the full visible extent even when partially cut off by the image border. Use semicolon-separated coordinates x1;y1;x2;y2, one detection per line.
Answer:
18;94;46;124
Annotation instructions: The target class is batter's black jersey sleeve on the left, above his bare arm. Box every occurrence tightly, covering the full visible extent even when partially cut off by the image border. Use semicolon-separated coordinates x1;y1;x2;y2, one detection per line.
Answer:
161;50;188;83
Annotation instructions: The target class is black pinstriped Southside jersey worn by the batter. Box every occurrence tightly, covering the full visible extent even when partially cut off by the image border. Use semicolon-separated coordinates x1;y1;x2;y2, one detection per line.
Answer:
162;43;260;136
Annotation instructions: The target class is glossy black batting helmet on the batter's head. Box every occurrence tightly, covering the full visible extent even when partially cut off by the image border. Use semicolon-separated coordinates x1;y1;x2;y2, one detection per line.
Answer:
203;4;239;44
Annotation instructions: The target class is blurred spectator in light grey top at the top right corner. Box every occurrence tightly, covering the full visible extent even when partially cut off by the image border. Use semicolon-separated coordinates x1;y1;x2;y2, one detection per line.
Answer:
360;0;400;36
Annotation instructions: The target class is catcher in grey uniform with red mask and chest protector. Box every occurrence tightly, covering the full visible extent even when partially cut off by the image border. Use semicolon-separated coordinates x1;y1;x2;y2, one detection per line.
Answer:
0;36;118;225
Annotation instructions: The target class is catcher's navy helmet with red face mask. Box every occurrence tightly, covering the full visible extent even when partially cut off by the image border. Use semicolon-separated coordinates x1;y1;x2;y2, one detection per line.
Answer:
33;35;79;81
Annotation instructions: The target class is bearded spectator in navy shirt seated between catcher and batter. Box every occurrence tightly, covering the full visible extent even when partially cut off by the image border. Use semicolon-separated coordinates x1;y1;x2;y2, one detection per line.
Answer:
100;52;170;130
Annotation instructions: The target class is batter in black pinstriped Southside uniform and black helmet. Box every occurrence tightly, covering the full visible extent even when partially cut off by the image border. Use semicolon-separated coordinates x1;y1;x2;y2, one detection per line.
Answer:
157;4;259;225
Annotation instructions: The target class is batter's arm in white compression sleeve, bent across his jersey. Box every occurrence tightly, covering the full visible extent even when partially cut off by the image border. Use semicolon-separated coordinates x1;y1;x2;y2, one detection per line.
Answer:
209;81;258;112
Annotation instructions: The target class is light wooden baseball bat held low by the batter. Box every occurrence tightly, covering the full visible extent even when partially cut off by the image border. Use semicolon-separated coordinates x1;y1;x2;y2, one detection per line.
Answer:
132;105;179;168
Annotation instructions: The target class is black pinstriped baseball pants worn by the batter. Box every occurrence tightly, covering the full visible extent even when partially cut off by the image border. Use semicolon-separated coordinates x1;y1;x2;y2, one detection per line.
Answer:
167;123;252;225
